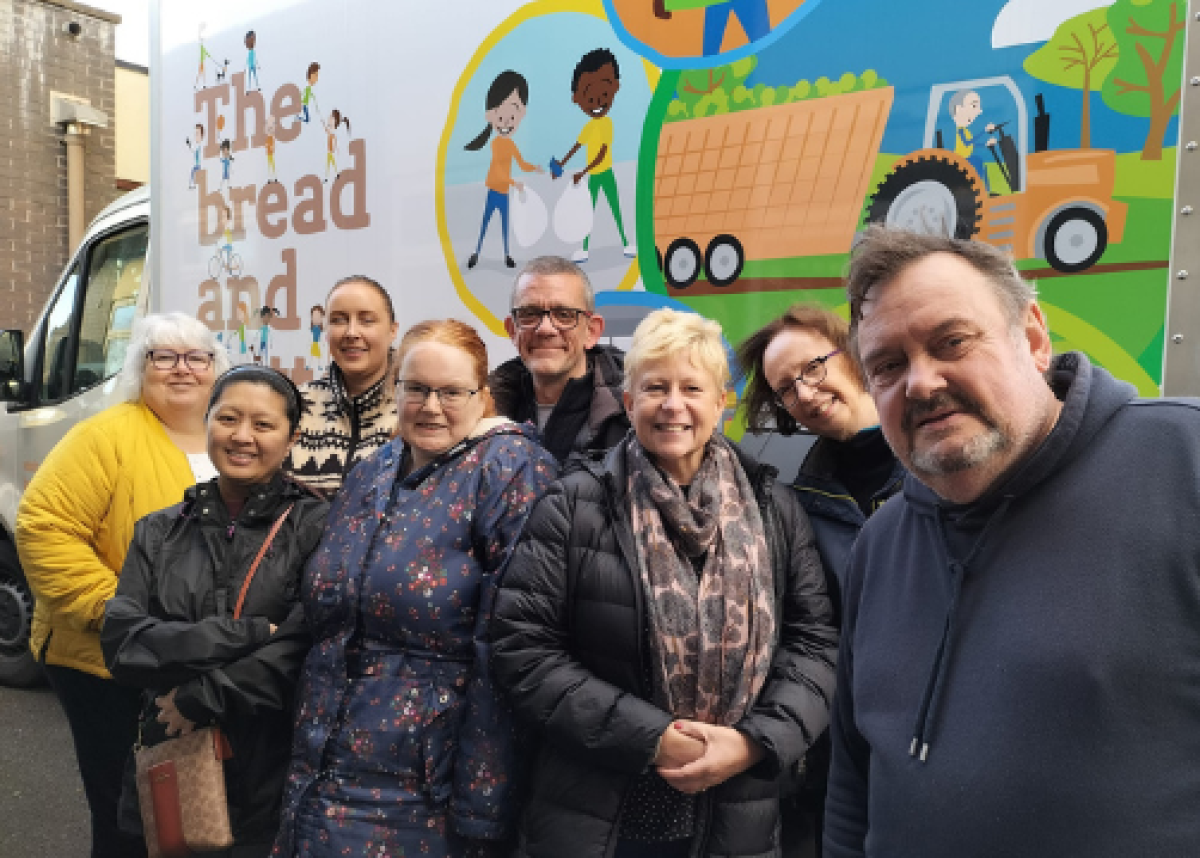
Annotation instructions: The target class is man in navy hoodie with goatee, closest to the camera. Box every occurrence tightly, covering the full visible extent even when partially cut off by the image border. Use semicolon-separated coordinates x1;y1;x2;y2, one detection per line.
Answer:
824;227;1200;858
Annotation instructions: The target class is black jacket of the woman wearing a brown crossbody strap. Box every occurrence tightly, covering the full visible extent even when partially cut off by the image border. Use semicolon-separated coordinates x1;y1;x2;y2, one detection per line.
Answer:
100;476;328;840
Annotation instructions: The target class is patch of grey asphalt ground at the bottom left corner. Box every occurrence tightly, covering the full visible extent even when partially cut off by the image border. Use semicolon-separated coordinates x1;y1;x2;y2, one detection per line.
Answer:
0;686;91;858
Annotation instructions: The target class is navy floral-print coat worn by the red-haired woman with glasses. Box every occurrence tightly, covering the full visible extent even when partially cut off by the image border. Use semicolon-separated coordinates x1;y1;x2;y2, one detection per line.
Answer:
274;420;556;858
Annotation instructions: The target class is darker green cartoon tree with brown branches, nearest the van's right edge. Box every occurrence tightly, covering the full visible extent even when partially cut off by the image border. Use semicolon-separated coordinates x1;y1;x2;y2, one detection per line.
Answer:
1102;0;1186;161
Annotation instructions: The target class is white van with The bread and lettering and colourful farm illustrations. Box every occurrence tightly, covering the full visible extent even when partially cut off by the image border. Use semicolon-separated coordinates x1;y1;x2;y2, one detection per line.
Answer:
0;0;1200;683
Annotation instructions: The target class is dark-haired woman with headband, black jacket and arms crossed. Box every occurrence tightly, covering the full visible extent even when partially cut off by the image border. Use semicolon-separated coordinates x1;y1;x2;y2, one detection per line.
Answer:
101;365;328;858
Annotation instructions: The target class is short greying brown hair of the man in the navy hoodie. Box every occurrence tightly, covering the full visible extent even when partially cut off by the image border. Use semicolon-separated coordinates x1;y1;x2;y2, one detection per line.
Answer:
846;224;1038;360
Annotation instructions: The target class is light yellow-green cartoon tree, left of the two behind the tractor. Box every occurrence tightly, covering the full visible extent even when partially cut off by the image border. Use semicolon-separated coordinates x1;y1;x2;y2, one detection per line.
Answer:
1025;8;1118;149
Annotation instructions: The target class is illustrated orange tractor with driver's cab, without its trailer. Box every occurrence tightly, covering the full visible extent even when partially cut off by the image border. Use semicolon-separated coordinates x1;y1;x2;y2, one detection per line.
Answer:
866;76;1128;272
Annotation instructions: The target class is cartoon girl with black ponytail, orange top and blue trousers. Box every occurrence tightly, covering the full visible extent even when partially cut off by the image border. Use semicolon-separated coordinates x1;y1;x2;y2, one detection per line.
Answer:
463;70;545;268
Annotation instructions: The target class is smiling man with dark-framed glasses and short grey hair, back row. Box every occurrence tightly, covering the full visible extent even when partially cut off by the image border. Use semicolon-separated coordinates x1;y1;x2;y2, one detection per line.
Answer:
488;256;629;464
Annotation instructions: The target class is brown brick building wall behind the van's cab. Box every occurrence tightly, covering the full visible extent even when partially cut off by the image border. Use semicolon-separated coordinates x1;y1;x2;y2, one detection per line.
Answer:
0;0;119;331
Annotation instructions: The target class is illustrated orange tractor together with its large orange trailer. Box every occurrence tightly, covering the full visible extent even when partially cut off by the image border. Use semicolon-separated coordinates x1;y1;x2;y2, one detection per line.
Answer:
654;76;1128;290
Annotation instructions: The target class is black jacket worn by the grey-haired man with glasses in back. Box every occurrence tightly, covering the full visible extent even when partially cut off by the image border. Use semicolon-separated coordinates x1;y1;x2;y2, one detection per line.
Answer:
487;346;629;464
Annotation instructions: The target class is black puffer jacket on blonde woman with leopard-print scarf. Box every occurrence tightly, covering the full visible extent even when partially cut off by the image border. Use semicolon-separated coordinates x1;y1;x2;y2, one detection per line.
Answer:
492;440;838;858
